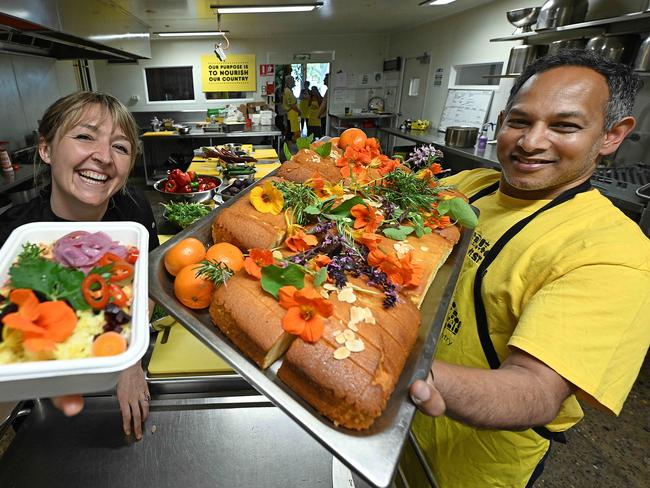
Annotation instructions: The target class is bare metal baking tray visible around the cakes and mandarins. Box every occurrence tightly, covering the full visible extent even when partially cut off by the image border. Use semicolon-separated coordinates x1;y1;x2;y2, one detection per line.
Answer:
149;181;472;487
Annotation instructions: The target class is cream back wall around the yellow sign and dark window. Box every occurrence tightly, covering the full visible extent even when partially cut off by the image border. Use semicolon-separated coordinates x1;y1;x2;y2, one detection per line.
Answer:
94;35;388;116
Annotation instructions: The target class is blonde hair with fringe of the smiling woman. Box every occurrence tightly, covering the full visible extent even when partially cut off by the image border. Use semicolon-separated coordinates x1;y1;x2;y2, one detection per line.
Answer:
34;91;140;185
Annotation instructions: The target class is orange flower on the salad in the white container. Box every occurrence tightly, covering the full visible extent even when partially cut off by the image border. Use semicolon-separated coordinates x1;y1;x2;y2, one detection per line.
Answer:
2;288;77;352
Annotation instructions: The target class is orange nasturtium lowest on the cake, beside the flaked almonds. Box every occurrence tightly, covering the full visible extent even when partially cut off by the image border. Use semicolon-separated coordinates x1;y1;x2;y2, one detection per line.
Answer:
279;286;334;342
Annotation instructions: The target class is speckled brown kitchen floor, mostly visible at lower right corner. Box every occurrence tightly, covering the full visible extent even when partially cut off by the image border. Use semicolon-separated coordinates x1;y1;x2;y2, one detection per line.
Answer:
0;180;650;488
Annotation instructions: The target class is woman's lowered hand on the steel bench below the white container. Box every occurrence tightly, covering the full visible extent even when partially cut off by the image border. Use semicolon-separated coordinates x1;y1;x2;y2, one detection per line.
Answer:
117;363;150;440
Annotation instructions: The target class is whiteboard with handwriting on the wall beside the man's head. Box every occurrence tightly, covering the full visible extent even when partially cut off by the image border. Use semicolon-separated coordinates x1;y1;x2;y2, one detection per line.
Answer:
438;88;494;131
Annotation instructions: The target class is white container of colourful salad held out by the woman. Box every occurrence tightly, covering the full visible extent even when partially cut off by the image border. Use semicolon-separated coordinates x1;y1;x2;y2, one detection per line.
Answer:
0;222;149;401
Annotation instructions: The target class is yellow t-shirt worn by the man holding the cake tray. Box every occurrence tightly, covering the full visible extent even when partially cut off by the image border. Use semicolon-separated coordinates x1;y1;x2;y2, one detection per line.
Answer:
413;169;650;488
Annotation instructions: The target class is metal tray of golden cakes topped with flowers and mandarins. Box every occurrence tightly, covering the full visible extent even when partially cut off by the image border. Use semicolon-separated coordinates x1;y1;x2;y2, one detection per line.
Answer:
150;131;476;486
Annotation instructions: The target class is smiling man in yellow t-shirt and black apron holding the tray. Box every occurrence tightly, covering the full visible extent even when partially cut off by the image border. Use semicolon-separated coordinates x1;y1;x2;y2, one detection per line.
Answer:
411;51;650;488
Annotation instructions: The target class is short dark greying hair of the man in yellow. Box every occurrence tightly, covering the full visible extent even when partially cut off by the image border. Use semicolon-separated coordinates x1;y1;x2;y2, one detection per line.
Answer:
506;49;641;130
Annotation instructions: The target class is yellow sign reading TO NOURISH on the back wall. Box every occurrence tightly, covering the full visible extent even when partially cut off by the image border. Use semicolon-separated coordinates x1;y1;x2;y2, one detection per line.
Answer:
201;54;257;92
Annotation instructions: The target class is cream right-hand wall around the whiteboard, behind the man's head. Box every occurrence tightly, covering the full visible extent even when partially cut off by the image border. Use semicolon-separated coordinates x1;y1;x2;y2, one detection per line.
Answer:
388;0;650;163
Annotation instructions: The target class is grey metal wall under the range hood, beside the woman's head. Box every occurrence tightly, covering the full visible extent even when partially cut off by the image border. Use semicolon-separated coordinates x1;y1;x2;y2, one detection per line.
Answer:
0;54;77;151
